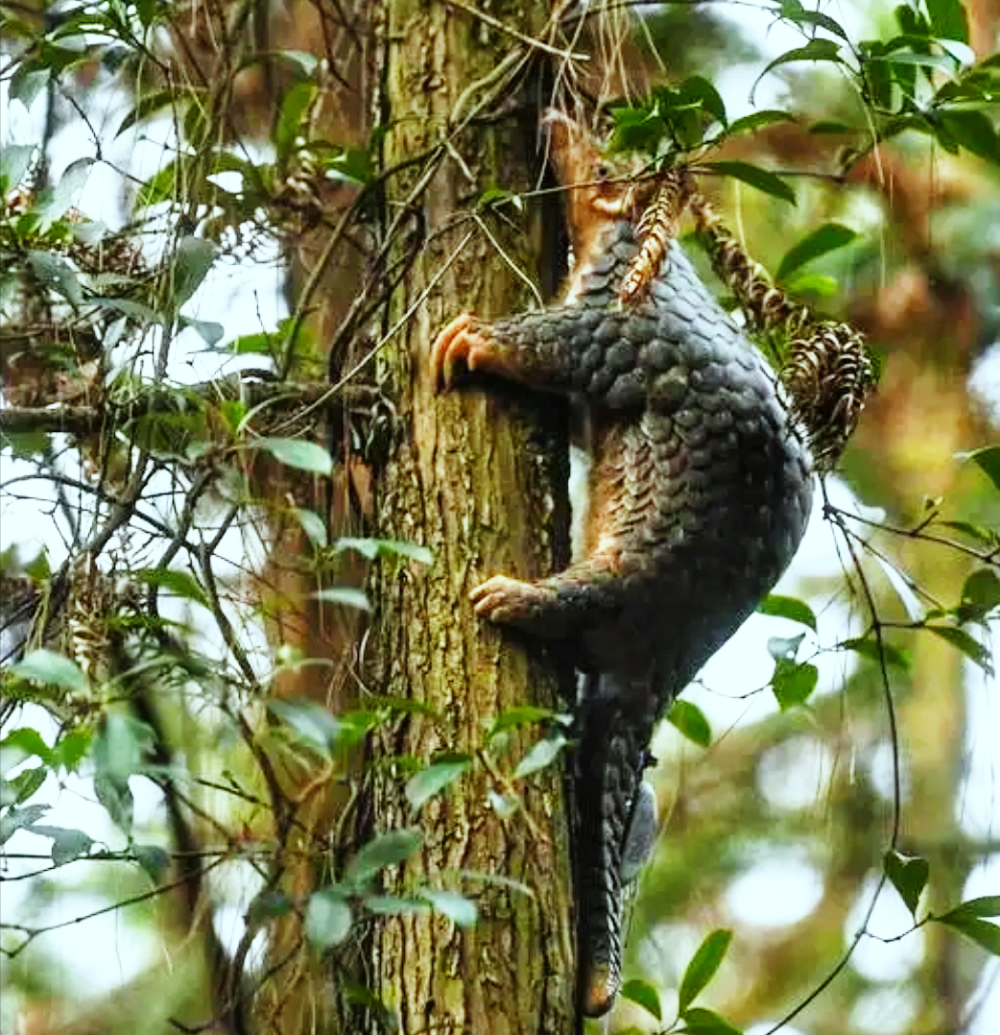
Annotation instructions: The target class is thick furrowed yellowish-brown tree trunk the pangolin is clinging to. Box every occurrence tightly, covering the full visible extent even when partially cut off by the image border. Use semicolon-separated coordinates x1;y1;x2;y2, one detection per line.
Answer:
372;0;573;1035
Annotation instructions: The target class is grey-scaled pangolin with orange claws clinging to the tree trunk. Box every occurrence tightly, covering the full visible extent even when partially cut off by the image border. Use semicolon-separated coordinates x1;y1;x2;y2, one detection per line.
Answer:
433;115;813;1015
